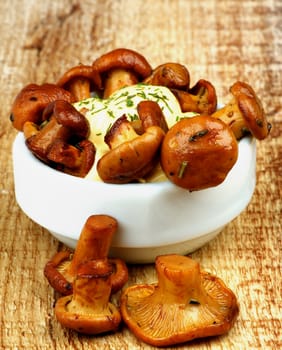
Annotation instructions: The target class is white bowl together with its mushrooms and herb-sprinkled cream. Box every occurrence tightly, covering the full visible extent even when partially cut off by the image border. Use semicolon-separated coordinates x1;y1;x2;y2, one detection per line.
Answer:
11;49;270;263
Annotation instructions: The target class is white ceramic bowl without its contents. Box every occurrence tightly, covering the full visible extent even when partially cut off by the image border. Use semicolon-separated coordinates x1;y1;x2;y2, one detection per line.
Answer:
13;133;256;263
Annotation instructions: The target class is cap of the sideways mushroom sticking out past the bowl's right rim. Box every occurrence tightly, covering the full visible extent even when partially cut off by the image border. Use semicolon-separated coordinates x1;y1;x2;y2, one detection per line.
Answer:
230;81;271;140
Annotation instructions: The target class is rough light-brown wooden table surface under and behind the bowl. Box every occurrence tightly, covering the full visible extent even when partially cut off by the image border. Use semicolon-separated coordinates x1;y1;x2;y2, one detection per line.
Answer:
0;0;282;350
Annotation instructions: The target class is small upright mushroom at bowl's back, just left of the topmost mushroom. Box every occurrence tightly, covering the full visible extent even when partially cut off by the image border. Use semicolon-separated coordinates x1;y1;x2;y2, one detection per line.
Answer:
57;65;102;101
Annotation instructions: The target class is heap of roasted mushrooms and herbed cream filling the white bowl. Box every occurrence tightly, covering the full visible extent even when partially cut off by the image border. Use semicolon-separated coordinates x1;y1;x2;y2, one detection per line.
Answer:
10;48;271;185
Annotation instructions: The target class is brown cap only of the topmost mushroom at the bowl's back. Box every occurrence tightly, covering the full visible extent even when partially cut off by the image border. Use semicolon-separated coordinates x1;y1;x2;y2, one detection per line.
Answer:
93;48;152;79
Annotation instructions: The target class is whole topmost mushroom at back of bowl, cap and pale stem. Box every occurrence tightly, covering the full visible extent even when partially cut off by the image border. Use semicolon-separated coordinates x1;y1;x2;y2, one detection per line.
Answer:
93;48;152;98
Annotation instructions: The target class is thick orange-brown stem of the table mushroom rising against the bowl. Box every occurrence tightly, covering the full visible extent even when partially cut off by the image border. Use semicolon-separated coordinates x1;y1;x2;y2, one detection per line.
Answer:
67;215;117;276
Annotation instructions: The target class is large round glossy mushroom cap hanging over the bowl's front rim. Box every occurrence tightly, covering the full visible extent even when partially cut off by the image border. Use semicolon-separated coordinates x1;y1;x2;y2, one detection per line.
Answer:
161;115;238;191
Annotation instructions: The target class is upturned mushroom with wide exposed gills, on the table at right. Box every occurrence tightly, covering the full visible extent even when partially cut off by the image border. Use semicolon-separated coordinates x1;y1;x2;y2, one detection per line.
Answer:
121;255;238;346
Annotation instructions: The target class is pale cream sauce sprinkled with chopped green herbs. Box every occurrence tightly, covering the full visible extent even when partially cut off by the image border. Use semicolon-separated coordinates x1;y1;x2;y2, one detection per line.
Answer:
74;84;195;182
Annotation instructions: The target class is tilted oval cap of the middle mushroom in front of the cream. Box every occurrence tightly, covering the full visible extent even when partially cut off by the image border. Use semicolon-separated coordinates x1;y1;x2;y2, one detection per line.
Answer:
97;126;164;184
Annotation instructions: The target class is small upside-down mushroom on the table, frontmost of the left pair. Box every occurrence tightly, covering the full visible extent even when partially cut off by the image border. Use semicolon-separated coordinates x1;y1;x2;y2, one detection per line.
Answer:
55;259;121;334
